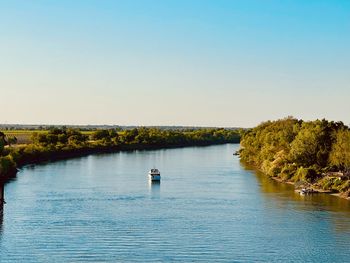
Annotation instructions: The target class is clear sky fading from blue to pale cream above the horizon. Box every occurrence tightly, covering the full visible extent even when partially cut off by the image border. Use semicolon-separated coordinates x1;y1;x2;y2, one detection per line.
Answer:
0;0;350;127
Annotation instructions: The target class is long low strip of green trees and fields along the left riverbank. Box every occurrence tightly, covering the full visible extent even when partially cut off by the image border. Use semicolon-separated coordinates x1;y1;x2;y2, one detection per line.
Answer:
0;127;240;182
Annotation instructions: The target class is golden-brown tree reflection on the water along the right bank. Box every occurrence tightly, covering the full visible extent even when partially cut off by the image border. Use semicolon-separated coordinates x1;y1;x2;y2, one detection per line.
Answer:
241;162;350;233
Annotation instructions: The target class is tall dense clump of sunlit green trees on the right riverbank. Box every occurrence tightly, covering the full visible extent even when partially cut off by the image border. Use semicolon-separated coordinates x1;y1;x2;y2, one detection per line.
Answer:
240;117;350;195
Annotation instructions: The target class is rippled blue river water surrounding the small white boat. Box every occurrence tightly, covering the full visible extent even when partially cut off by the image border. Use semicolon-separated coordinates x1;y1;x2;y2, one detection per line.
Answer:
0;144;350;262
